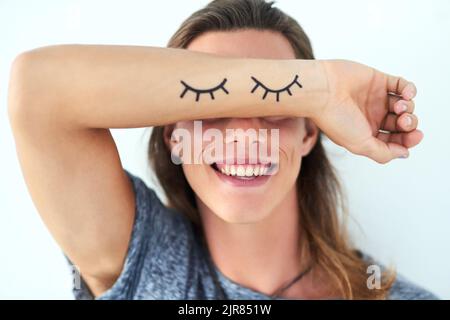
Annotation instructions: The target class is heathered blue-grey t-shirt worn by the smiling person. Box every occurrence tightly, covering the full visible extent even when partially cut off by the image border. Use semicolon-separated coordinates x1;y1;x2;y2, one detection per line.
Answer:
69;171;437;300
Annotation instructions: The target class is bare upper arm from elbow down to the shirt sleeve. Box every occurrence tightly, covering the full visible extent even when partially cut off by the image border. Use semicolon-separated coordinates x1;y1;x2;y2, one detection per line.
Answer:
8;50;135;294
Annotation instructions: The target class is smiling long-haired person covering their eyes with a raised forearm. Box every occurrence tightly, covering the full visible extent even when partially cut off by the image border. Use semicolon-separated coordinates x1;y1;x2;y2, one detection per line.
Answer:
8;0;436;299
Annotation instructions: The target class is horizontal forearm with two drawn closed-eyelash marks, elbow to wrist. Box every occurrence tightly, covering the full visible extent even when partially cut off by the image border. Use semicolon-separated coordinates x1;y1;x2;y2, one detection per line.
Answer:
8;45;327;128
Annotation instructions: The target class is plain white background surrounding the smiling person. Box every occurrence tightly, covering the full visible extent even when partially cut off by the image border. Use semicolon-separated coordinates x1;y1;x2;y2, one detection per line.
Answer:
0;0;450;299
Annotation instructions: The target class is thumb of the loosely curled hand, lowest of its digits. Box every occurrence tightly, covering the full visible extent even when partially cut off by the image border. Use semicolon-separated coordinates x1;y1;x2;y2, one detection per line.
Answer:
366;137;409;164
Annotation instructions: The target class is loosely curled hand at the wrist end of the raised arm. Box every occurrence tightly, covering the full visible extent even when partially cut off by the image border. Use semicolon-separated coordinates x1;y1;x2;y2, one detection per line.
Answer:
312;60;423;163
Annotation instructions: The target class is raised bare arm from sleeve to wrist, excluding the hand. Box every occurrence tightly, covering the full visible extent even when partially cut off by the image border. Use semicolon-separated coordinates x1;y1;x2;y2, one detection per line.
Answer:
8;45;326;294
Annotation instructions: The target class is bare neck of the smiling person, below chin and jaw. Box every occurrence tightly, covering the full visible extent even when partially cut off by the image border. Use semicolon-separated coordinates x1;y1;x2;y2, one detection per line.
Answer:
198;187;306;295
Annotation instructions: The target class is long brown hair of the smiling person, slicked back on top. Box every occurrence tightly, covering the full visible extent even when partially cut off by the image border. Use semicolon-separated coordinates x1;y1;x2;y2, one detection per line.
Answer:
148;0;395;299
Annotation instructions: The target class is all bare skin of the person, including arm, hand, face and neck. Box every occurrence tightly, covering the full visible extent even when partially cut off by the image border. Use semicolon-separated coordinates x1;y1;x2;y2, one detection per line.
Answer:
8;30;422;297
